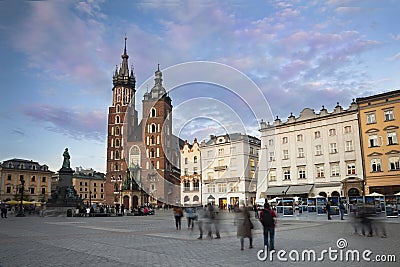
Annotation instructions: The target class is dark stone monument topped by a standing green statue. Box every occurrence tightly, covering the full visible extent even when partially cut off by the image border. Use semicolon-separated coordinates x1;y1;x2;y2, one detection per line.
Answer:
47;148;83;213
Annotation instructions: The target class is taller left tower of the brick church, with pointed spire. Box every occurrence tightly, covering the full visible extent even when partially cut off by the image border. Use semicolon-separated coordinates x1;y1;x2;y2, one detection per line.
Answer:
105;37;137;205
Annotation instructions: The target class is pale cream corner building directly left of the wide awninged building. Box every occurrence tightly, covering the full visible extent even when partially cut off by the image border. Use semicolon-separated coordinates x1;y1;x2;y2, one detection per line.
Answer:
200;133;261;208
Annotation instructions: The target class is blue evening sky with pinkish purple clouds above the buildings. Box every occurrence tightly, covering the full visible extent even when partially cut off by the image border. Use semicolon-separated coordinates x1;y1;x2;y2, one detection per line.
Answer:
0;0;400;172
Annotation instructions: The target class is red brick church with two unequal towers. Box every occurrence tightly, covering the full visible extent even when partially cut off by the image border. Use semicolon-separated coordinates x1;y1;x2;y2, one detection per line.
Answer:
105;38;183;210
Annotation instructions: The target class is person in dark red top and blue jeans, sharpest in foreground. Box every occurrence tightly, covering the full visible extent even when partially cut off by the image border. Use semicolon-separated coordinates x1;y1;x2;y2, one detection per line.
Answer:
260;202;277;251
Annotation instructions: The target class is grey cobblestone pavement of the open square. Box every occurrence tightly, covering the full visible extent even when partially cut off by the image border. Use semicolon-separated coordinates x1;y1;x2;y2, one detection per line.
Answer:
0;211;400;267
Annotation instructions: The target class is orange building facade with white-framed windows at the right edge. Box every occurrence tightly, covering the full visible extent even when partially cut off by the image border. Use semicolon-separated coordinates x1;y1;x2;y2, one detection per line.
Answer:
356;90;400;195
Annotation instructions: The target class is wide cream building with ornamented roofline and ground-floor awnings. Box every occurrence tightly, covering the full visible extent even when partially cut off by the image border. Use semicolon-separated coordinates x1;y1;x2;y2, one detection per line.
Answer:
257;102;363;198
